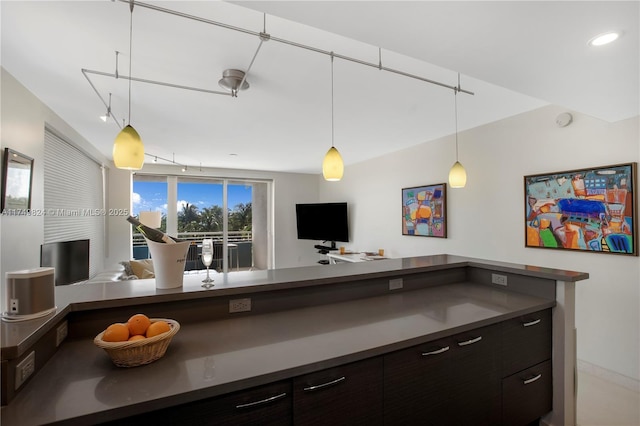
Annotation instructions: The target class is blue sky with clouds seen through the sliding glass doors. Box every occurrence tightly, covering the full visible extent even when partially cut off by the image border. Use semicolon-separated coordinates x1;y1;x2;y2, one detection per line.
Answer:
132;181;251;216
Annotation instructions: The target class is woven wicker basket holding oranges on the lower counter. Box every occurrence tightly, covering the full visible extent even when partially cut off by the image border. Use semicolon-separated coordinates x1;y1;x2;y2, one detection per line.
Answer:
93;318;180;367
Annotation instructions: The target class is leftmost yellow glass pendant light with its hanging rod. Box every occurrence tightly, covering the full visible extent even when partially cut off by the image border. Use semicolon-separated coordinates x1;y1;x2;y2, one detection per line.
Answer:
113;0;144;170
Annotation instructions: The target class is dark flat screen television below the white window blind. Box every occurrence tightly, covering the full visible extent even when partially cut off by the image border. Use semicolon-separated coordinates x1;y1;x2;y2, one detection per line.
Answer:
40;240;89;285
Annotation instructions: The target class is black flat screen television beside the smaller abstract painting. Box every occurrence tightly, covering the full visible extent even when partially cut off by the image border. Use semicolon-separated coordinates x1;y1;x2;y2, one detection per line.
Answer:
296;203;349;247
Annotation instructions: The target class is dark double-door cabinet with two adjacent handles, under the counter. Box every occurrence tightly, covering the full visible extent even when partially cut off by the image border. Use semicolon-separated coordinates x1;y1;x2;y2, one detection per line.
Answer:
384;325;501;425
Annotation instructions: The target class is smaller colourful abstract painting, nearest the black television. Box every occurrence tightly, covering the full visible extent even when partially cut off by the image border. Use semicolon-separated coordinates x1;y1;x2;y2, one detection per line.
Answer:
402;183;447;238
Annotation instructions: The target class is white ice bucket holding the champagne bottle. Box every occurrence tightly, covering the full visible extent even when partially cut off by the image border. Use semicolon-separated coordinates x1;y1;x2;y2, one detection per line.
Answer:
146;239;191;288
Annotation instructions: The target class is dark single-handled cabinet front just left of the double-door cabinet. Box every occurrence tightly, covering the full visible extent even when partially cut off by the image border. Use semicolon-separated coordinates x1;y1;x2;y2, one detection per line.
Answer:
293;357;382;426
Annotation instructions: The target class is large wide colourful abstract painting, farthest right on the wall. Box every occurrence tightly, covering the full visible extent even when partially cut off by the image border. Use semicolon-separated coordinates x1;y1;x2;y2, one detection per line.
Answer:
524;163;638;256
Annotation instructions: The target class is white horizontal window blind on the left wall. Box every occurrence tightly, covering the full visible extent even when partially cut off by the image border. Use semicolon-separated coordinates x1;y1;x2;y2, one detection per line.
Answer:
44;128;106;277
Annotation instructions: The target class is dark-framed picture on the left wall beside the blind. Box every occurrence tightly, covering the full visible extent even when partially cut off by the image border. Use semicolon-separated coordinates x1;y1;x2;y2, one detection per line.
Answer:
0;148;33;214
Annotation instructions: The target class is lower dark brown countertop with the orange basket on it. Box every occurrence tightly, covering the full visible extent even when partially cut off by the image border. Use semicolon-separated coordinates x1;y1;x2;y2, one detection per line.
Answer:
1;280;556;426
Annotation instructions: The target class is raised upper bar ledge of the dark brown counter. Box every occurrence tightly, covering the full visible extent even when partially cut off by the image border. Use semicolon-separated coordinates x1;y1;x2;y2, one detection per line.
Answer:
0;254;589;360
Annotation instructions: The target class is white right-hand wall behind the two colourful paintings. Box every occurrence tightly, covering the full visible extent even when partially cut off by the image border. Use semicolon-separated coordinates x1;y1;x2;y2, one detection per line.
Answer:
320;106;640;380
